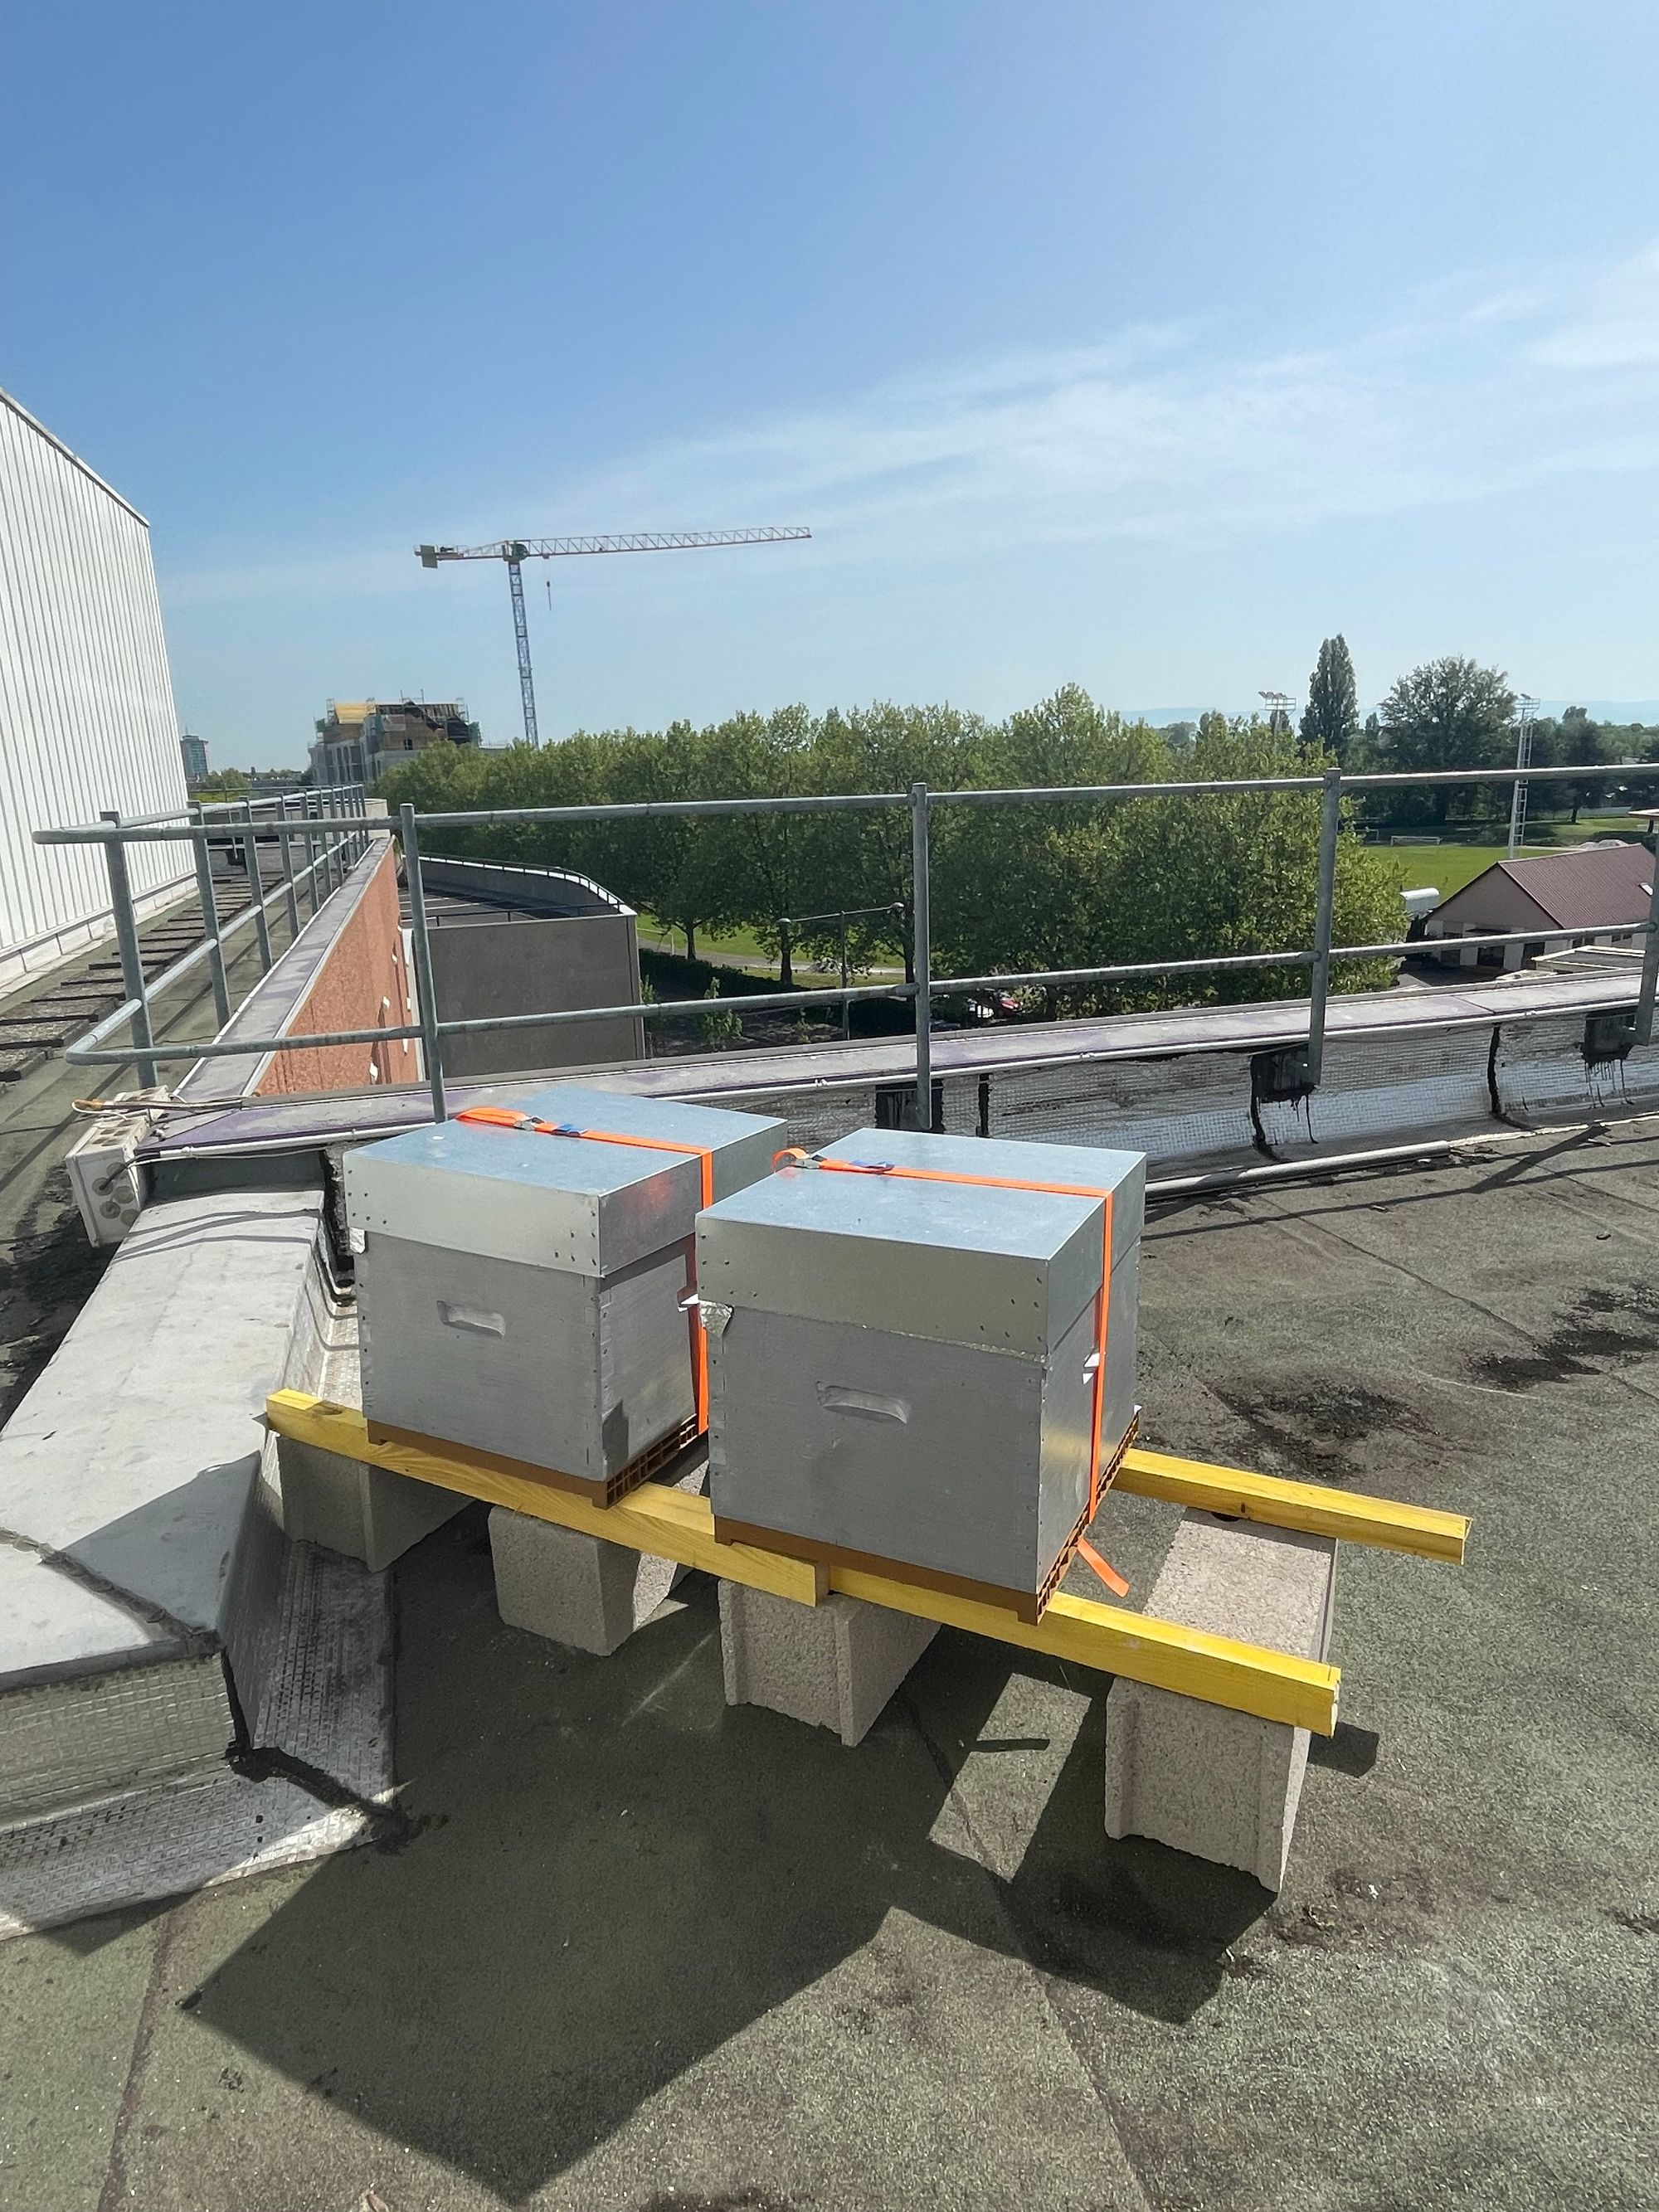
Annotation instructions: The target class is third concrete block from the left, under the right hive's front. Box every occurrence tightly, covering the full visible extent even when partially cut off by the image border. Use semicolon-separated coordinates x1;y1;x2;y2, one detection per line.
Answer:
719;1582;938;1745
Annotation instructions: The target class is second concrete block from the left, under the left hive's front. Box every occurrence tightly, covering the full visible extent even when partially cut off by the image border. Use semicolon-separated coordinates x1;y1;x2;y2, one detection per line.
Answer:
489;1462;708;1659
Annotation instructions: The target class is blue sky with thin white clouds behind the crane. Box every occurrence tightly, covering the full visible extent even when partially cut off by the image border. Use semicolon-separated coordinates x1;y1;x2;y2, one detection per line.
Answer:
0;0;1659;761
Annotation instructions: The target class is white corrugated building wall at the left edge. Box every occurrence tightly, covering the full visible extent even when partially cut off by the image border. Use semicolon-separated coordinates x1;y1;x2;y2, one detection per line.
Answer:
0;391;190;989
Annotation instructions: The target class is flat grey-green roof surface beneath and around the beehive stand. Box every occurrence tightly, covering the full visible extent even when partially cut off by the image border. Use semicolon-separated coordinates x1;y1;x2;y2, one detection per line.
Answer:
0;1124;1659;2212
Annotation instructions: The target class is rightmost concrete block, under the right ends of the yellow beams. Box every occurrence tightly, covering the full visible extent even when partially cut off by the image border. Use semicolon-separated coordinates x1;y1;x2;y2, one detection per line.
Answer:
1106;1513;1336;1889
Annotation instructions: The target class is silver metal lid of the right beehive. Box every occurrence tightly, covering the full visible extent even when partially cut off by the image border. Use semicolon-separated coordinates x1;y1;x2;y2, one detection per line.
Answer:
697;1128;1144;1359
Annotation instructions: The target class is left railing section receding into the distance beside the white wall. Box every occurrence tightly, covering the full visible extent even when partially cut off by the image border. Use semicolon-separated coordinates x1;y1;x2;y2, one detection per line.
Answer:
36;783;369;1086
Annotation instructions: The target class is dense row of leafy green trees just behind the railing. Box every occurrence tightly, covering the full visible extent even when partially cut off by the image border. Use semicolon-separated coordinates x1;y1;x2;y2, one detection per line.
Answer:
382;686;1403;1006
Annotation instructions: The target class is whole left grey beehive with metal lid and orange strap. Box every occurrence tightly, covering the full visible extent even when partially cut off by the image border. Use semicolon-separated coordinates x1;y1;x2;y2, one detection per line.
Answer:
345;1084;786;1500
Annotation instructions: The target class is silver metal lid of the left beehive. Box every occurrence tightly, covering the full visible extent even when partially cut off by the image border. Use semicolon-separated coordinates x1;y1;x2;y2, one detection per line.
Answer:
345;1084;783;1276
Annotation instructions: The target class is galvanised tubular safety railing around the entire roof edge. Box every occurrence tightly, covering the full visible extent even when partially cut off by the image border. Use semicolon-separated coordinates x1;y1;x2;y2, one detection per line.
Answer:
36;761;1659;1128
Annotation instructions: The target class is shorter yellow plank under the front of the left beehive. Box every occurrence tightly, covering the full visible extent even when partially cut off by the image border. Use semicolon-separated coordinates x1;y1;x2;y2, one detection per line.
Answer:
265;1389;827;1606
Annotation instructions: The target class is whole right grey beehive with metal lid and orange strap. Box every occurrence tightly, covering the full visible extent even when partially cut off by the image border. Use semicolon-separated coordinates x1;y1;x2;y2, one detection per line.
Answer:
697;1128;1146;1619
